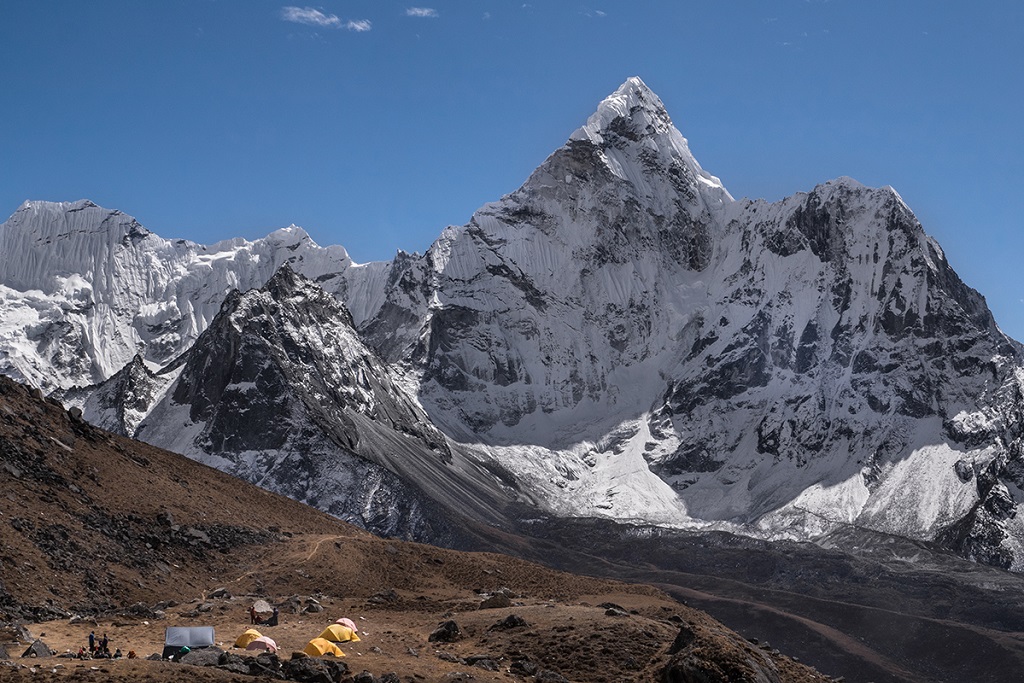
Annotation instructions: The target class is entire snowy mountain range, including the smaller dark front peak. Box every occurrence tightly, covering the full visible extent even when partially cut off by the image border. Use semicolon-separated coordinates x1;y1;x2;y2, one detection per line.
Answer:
0;79;1024;569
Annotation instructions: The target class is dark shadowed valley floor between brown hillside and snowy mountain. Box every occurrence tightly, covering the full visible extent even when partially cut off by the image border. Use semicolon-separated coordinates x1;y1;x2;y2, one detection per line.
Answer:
483;519;1024;683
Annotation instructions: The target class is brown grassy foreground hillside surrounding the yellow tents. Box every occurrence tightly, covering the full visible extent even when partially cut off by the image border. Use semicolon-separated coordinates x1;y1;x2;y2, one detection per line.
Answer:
0;378;829;683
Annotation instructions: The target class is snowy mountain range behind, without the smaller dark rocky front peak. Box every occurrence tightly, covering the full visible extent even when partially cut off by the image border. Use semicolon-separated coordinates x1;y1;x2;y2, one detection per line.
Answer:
0;79;1024;569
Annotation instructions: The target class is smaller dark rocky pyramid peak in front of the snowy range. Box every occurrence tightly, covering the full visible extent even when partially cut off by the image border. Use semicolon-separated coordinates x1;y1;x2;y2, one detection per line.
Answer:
126;265;512;545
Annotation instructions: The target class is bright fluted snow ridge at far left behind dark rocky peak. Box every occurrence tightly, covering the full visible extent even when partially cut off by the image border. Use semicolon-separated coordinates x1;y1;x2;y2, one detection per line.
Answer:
0;200;380;389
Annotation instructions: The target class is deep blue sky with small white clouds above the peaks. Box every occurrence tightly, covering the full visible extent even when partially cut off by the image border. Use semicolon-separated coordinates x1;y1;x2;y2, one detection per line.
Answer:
6;0;1024;340
